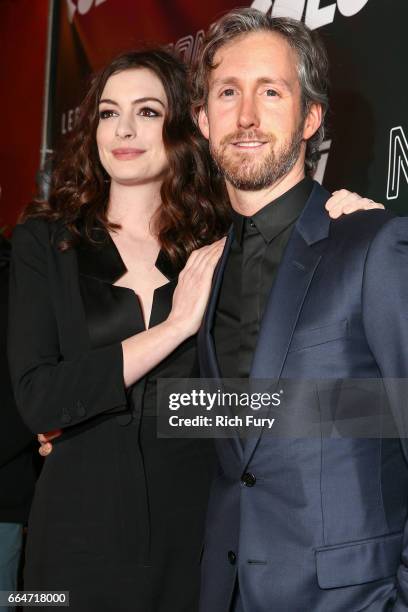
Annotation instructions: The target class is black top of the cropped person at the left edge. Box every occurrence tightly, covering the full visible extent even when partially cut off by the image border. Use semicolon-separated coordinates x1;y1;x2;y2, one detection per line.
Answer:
0;235;36;523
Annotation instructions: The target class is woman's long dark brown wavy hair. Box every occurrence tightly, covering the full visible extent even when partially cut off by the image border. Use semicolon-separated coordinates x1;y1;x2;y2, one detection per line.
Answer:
20;48;229;266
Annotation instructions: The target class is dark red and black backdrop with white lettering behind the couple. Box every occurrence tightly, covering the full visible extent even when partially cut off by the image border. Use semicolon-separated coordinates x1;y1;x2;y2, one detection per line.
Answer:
1;0;408;228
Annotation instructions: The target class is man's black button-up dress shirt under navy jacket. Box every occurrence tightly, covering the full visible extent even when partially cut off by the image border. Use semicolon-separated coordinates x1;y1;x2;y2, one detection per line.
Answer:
213;178;313;378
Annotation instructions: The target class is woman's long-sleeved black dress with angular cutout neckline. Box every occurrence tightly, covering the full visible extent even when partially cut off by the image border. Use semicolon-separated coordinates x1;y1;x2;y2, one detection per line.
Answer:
10;221;215;612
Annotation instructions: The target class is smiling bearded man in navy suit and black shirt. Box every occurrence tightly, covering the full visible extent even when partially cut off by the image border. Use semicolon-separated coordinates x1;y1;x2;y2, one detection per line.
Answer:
195;9;408;612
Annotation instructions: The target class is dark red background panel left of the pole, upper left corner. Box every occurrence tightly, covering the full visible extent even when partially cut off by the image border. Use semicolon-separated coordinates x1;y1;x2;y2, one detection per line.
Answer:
0;0;48;233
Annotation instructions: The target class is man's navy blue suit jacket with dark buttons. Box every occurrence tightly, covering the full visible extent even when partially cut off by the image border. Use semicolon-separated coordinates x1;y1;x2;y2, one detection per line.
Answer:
199;183;408;612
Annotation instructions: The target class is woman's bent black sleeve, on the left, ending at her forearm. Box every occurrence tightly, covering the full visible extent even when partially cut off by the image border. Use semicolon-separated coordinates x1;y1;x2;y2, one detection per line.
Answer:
8;222;127;433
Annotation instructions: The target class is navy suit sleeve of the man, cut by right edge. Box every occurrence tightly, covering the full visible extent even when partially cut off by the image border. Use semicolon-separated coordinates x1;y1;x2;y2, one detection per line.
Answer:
363;217;408;612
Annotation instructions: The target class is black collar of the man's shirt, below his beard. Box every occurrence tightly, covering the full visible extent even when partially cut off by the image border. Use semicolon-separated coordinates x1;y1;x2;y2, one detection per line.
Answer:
232;177;313;244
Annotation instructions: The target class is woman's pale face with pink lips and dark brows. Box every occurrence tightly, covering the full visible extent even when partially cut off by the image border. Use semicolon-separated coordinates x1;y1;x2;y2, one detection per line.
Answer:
96;68;168;185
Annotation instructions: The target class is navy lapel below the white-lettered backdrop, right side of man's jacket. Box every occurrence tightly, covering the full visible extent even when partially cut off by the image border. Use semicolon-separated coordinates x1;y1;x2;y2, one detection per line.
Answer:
244;183;330;465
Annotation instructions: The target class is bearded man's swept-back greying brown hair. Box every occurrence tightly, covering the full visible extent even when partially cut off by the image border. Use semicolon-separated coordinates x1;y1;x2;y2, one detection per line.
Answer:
192;8;329;174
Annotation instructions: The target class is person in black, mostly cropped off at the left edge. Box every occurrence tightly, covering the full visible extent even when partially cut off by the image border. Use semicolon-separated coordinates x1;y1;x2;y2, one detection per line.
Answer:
0;234;36;611
